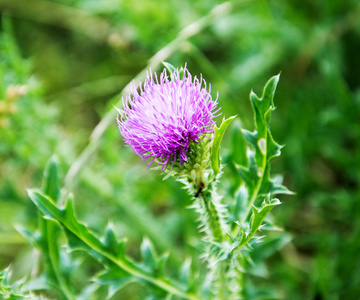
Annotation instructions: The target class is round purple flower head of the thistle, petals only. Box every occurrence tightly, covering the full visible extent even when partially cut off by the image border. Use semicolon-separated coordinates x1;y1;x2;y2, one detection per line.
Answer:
117;67;220;170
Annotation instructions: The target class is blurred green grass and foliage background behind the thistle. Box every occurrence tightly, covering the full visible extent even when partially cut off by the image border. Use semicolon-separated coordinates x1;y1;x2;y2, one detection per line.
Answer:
0;0;360;299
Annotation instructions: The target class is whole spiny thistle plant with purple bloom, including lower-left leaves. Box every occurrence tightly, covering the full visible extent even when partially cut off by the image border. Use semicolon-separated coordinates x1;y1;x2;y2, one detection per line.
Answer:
19;63;290;300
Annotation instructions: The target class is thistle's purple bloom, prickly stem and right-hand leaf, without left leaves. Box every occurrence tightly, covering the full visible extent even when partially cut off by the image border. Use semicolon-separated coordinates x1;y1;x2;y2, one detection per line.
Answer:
118;64;290;299
